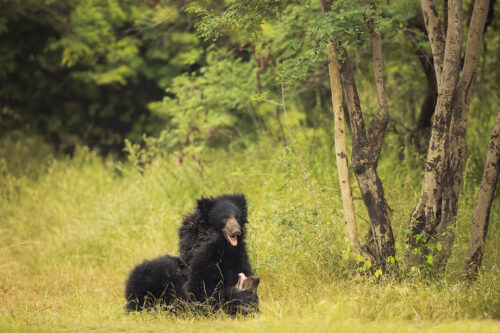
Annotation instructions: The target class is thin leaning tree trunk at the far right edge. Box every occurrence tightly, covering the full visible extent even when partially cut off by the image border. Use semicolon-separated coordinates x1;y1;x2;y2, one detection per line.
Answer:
464;113;500;279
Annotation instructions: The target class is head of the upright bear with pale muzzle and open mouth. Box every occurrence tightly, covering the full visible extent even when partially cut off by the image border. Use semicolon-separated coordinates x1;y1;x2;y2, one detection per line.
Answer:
197;193;247;246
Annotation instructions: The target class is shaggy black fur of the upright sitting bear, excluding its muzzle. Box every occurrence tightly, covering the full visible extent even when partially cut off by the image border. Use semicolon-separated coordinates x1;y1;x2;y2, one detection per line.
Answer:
179;194;252;302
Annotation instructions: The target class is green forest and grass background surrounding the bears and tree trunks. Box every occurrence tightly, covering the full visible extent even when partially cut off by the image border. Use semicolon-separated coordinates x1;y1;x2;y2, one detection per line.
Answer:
0;0;500;332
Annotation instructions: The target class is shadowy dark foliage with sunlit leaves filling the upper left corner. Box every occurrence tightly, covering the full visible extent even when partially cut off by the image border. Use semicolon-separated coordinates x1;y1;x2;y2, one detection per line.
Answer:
0;0;203;152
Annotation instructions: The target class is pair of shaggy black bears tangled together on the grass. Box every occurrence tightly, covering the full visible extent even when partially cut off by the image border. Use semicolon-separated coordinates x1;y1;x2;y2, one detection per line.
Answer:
125;194;259;314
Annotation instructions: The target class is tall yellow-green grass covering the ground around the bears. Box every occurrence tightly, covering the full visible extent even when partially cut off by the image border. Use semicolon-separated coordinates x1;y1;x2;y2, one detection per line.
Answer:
0;137;500;332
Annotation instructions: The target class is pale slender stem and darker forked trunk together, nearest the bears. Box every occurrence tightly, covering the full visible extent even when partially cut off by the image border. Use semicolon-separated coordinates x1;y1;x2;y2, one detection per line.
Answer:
320;0;394;269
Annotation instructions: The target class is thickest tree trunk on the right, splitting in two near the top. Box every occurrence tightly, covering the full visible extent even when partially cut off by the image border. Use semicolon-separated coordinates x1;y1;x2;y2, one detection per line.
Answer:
409;0;489;268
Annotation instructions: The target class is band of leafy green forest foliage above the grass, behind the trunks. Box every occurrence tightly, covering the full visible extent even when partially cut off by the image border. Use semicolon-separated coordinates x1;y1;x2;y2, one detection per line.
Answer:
0;0;499;163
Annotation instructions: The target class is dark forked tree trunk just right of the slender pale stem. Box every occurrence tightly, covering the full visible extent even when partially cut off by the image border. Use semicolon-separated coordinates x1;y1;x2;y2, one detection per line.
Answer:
334;1;395;270
